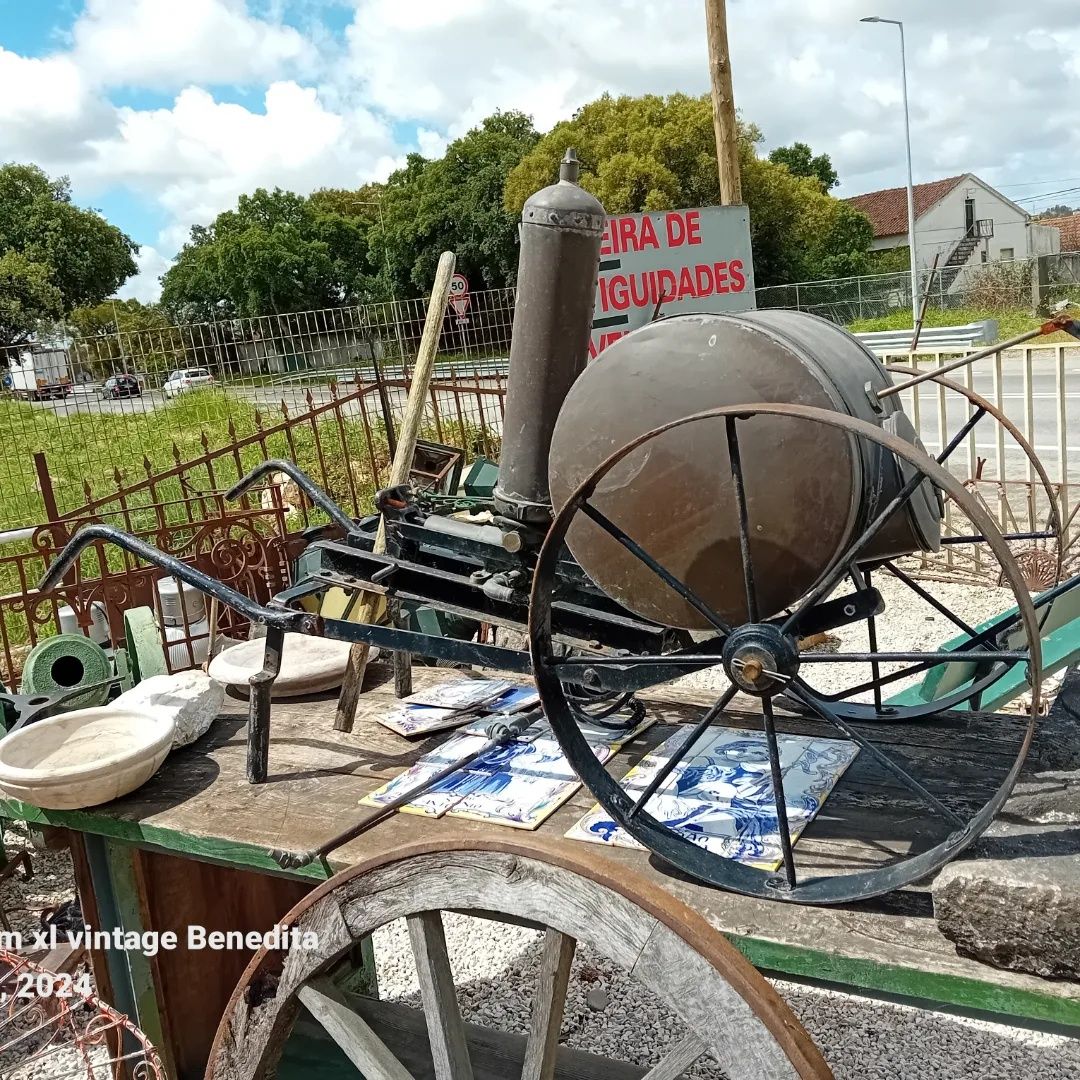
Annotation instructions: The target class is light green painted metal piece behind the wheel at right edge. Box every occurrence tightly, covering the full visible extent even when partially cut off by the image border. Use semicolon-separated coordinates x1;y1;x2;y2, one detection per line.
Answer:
885;589;1080;713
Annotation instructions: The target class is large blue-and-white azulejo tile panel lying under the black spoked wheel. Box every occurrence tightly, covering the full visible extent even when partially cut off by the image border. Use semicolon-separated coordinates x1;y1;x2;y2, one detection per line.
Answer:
566;728;859;869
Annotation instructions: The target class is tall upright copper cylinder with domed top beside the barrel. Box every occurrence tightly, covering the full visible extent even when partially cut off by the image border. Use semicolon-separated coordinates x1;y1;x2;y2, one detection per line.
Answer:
495;150;607;527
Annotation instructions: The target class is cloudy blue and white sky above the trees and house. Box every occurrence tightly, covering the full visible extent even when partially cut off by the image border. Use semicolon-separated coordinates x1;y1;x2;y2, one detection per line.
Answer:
0;0;1080;298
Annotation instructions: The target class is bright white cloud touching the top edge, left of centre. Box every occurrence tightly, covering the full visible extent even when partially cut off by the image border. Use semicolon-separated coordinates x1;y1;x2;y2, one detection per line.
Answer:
72;0;315;90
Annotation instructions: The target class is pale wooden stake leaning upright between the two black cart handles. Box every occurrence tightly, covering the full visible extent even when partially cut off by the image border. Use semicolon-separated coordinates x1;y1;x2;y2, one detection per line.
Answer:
334;252;457;731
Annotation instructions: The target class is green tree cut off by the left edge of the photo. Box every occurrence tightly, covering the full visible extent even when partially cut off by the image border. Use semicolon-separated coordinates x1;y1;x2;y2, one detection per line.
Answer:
0;163;138;345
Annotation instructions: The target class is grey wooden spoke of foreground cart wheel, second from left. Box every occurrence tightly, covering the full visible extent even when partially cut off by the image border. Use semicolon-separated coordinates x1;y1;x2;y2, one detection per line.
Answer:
407;912;473;1080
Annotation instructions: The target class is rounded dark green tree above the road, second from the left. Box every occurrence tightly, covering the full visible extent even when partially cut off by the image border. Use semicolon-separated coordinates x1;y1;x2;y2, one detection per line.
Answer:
161;188;378;321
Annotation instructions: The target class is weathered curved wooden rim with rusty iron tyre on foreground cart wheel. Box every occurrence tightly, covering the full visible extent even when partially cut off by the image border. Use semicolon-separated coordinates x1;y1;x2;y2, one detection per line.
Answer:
206;837;832;1080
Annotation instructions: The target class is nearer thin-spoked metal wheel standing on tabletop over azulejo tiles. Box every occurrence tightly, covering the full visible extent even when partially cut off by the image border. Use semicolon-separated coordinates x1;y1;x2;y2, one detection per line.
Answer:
530;404;1041;904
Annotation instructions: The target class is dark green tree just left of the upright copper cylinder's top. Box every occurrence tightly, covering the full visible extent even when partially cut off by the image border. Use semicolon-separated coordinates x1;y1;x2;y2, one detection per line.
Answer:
370;112;540;296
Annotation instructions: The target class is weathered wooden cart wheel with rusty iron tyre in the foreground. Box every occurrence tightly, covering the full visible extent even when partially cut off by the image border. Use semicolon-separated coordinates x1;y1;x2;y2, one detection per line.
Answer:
206;837;833;1080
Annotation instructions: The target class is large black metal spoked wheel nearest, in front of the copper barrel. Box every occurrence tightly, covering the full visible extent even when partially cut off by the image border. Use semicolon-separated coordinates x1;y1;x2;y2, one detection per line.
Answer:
529;404;1041;904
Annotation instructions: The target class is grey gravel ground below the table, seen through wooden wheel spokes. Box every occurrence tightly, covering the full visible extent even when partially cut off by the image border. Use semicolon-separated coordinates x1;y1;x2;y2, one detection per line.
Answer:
375;914;1080;1080
